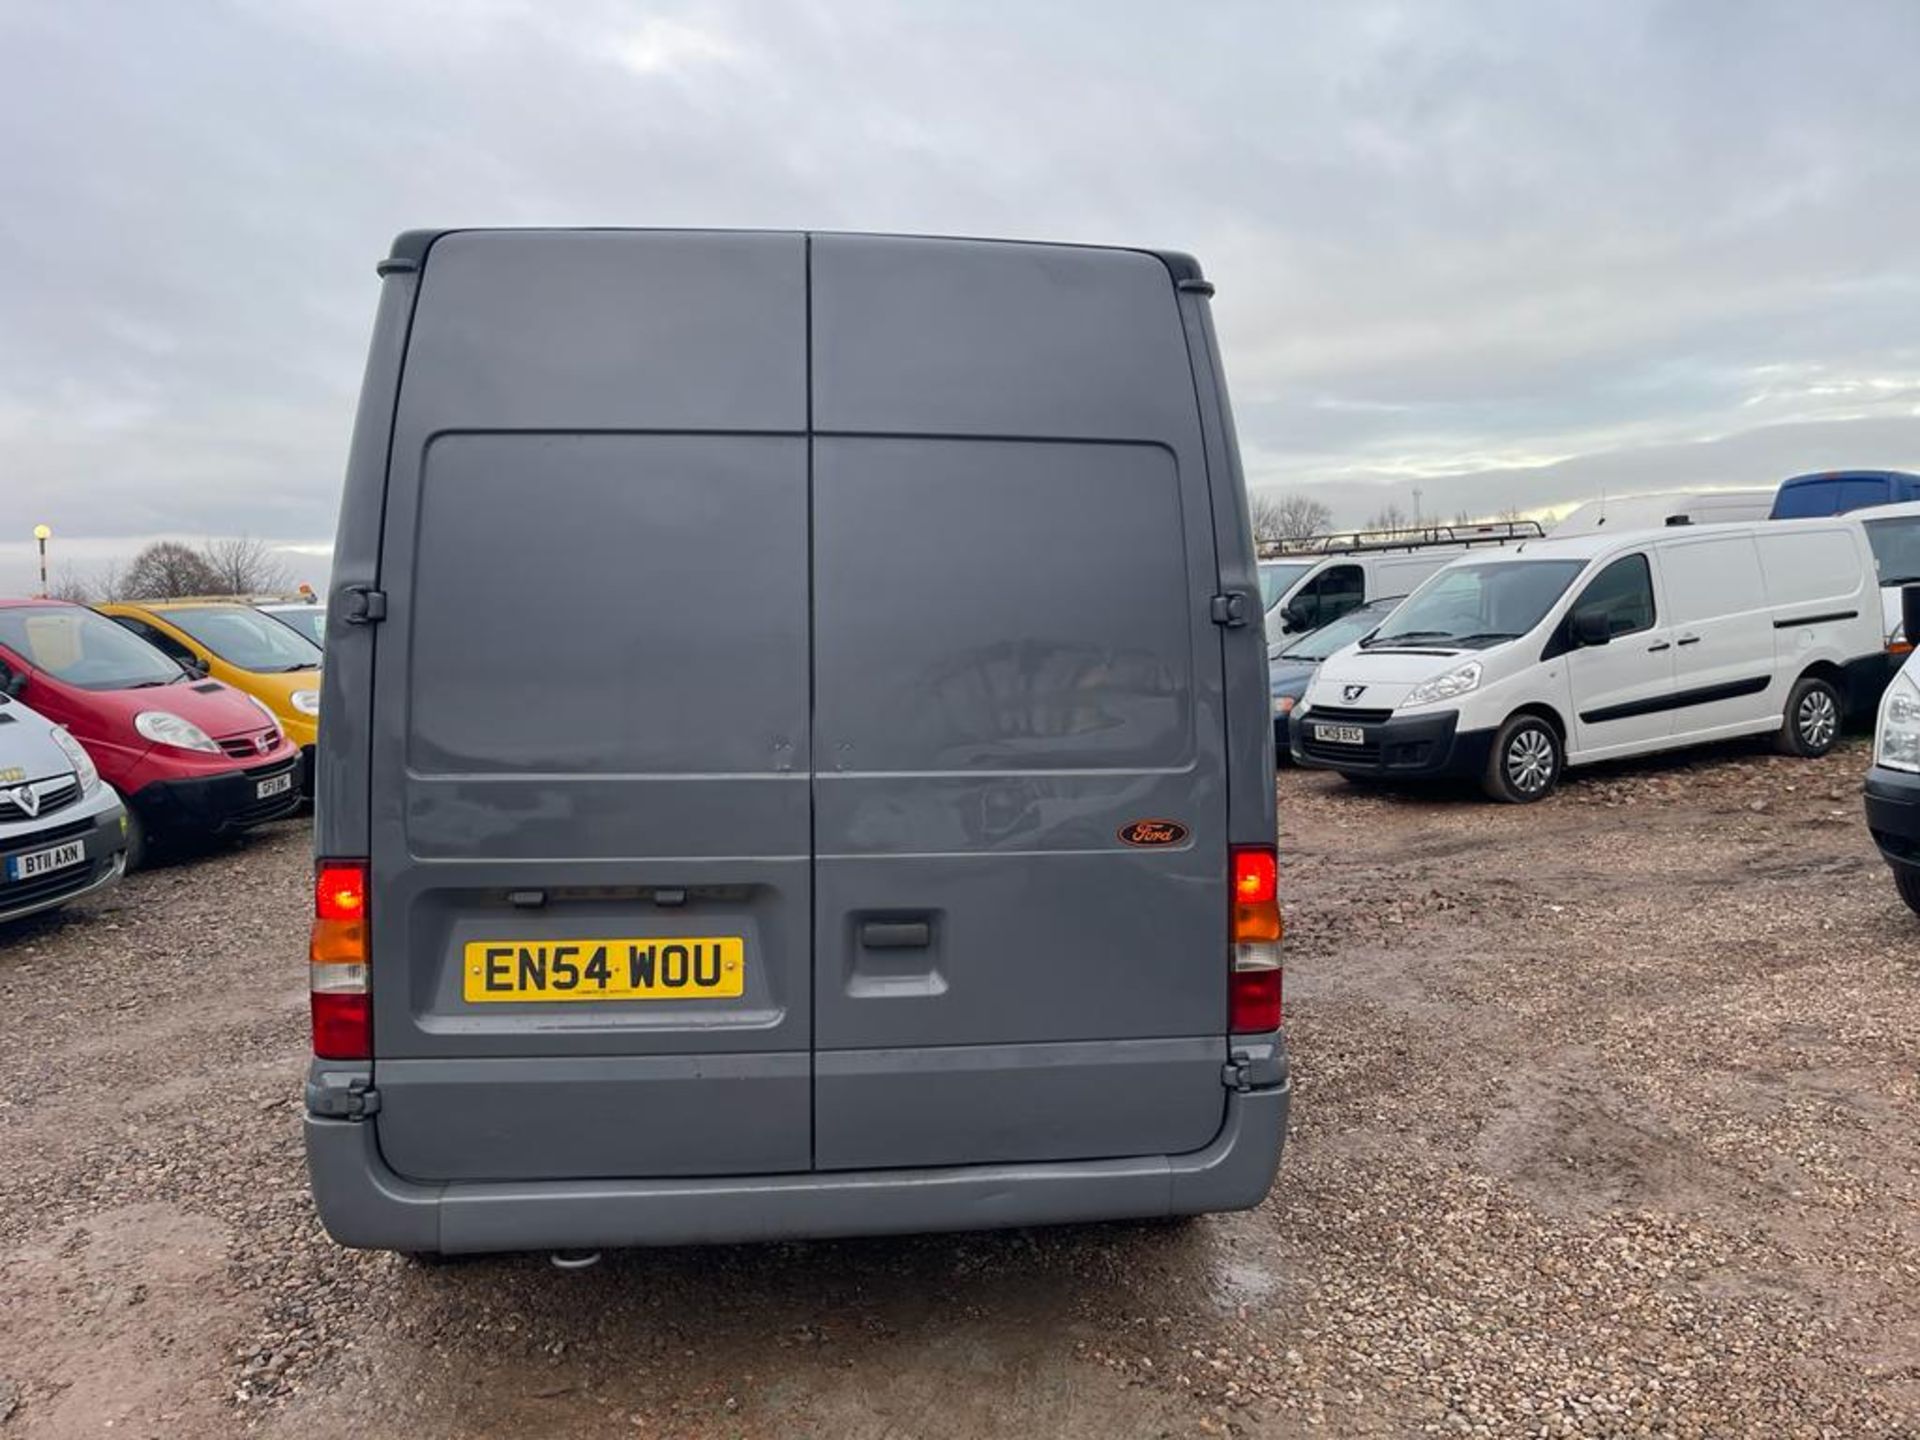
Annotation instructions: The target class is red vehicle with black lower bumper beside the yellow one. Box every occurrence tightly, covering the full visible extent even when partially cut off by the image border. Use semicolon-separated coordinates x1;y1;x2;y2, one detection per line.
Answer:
0;599;300;868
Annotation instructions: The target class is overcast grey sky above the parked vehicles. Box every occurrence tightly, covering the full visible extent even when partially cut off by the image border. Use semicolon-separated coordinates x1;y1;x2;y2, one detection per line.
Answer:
0;0;1920;593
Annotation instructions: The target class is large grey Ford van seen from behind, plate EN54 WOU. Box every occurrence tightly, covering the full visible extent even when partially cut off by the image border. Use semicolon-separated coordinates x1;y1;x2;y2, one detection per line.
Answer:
307;230;1290;1252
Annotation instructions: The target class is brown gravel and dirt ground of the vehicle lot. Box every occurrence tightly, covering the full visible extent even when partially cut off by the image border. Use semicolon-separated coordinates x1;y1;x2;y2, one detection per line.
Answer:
0;741;1920;1440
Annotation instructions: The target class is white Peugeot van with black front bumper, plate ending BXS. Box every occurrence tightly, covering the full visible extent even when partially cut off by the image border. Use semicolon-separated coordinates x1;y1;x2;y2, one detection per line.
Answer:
1290;518;1887;803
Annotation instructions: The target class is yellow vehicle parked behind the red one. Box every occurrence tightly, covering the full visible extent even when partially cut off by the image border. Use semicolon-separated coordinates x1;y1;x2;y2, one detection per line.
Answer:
94;599;321;795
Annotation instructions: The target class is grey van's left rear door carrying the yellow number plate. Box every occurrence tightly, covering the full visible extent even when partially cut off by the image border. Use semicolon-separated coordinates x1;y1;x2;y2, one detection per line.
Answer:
362;232;812;1181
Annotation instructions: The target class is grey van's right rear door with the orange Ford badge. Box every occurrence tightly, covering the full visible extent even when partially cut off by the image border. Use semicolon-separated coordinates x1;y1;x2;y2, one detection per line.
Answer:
812;236;1228;1169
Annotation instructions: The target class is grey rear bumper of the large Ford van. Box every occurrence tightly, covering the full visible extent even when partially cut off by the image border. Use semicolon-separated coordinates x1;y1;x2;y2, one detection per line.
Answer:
307;1077;1292;1254
